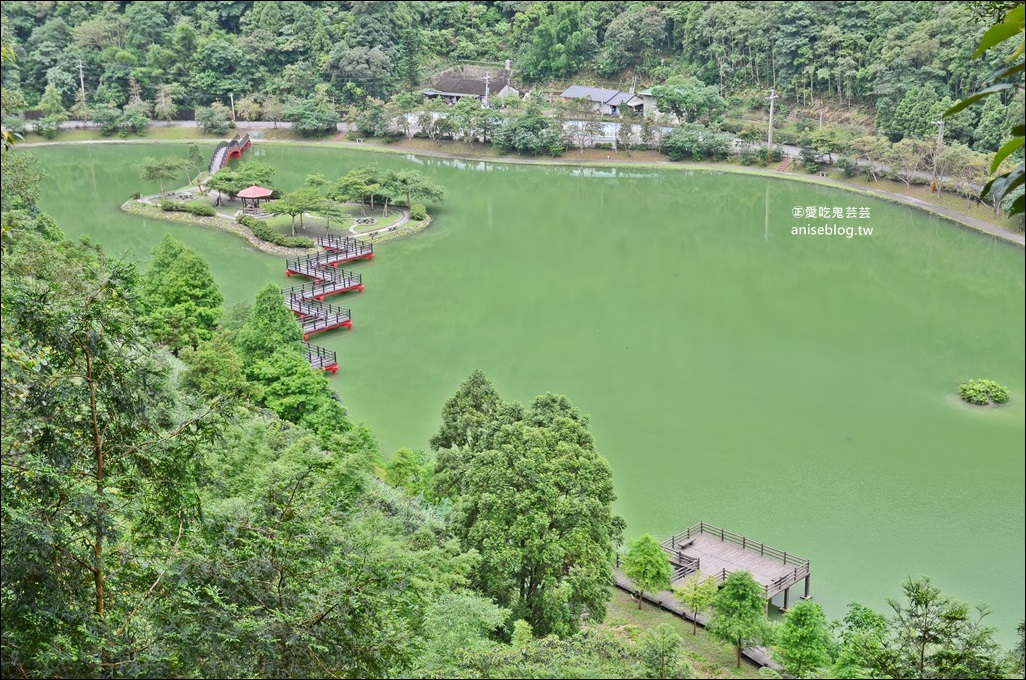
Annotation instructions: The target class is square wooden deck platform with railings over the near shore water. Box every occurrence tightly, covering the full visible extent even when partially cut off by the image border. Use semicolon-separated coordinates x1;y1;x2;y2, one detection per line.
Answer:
662;522;812;609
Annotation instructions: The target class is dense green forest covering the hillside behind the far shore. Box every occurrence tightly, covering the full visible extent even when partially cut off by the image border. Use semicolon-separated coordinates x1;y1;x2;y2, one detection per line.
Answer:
3;2;1021;138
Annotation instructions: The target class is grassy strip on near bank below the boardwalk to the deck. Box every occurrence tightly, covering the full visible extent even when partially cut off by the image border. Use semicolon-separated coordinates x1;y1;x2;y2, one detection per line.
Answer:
605;588;761;678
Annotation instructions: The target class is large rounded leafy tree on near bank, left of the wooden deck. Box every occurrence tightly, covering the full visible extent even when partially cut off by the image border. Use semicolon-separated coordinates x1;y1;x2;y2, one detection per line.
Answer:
436;376;623;635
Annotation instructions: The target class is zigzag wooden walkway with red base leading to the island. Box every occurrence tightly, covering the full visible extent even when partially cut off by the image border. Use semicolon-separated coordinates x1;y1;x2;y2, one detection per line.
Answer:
282;235;374;373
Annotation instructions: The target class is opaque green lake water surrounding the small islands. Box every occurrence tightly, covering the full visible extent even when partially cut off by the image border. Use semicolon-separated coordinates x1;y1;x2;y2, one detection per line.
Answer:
36;145;1026;642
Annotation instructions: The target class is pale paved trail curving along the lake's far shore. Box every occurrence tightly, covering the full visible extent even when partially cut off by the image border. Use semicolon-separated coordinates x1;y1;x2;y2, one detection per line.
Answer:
17;134;1026;248
